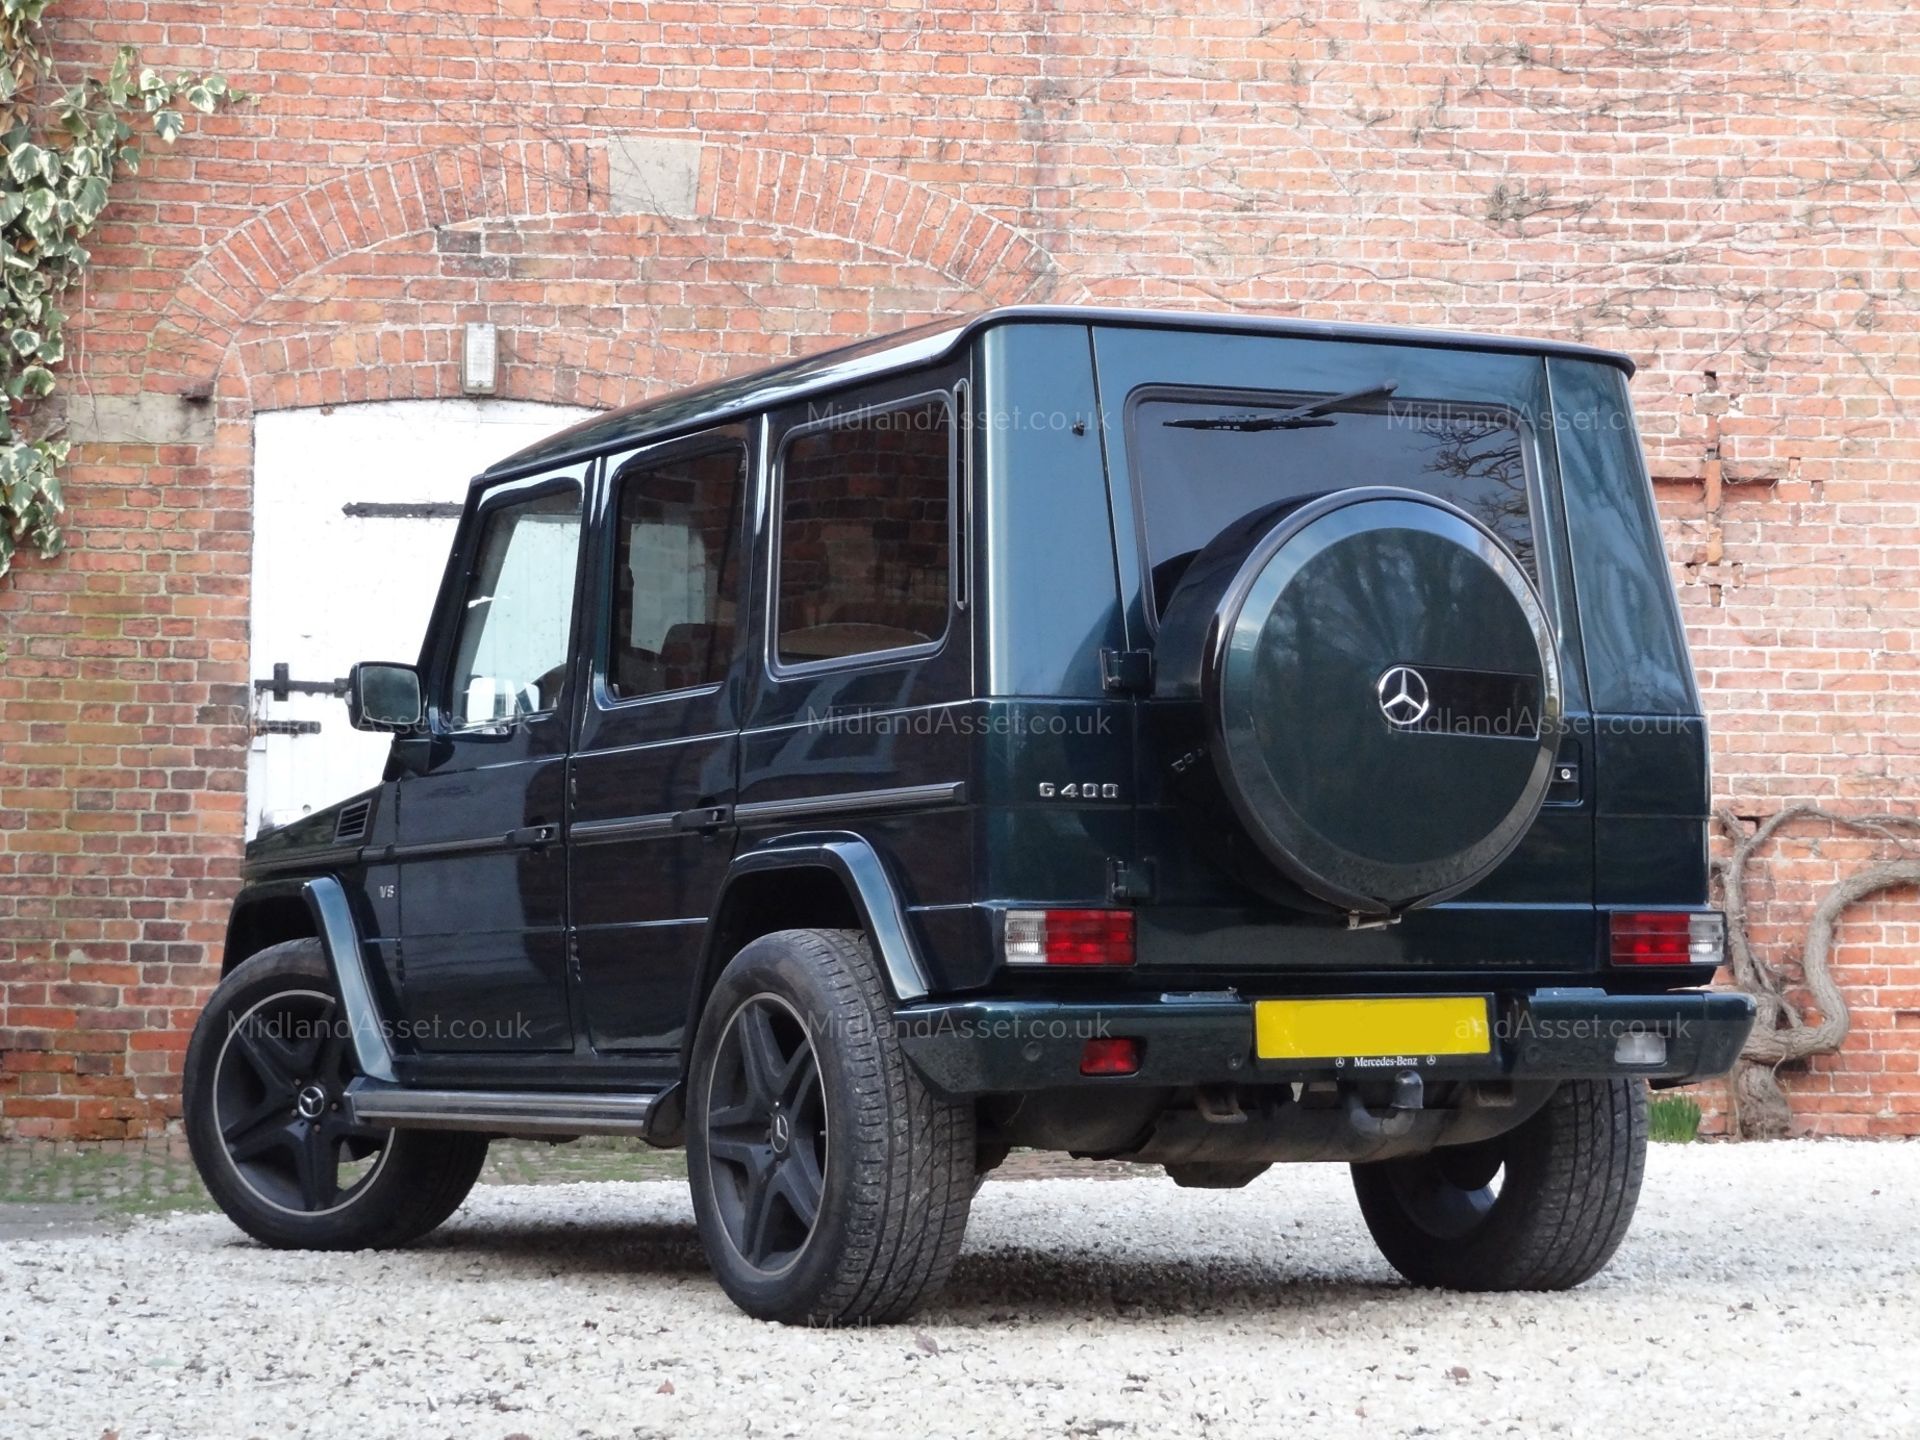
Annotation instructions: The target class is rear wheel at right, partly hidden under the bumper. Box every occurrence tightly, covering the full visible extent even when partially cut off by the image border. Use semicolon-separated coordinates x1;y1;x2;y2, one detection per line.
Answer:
1354;1079;1647;1290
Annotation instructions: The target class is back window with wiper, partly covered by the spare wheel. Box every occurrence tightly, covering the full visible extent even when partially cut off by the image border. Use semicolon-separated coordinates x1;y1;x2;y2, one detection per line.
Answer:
1127;390;1540;614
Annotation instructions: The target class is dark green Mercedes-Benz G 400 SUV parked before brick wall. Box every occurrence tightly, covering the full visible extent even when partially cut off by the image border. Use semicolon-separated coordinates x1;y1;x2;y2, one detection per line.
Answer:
186;309;1751;1323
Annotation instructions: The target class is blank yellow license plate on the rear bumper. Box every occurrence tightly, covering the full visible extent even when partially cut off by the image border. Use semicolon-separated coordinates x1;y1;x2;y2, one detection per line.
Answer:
1254;995;1494;1060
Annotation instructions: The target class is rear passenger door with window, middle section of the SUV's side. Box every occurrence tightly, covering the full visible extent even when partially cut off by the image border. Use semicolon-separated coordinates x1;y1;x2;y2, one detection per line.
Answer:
568;426;753;1050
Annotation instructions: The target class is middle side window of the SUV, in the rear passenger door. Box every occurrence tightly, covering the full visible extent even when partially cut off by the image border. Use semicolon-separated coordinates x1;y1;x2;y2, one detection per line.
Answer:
607;445;747;699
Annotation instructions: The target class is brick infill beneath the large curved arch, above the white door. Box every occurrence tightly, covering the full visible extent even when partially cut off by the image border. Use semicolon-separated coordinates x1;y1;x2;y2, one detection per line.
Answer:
217;217;1029;420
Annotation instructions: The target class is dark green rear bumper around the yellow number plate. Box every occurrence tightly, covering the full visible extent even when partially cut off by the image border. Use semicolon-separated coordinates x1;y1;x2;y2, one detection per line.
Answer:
895;989;1753;1096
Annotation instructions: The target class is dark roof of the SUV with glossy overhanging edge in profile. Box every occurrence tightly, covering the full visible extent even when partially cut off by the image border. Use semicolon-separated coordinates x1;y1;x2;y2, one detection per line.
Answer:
480;305;1634;480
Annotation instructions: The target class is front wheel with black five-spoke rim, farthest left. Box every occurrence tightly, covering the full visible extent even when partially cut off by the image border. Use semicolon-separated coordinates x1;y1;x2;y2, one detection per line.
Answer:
182;939;488;1250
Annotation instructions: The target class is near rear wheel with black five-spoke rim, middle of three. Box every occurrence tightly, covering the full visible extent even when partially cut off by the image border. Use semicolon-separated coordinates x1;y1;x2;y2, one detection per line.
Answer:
687;929;975;1325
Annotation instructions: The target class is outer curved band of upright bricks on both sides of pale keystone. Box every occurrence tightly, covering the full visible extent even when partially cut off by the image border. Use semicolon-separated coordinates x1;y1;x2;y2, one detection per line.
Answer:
144;142;1054;396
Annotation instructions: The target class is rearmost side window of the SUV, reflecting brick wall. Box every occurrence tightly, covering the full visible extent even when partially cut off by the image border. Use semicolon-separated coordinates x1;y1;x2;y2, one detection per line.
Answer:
774;396;954;664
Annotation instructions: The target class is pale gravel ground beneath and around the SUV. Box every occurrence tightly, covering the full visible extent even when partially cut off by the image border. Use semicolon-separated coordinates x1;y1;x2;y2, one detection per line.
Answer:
0;1142;1920;1440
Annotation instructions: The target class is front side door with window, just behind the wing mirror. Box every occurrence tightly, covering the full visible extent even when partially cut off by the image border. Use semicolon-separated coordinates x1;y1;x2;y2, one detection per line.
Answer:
394;467;588;1052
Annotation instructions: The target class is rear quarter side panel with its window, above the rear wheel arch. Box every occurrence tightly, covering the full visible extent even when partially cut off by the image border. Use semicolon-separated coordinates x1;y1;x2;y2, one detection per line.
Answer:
737;374;979;964
